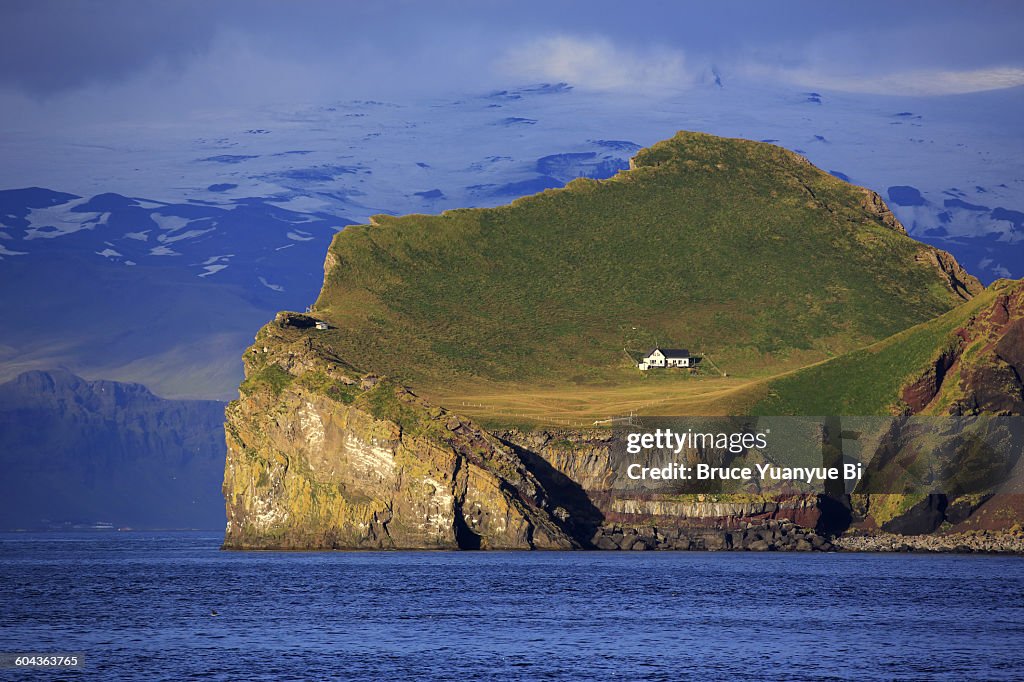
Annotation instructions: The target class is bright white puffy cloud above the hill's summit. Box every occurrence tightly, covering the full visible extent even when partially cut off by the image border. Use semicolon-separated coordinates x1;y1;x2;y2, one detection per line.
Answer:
498;35;694;91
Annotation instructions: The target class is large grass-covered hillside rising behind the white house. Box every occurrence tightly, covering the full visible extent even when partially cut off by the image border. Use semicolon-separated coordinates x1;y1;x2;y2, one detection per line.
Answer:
315;133;980;389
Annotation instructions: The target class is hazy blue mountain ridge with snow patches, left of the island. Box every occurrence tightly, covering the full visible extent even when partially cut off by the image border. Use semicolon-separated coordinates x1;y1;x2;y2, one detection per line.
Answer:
0;187;350;398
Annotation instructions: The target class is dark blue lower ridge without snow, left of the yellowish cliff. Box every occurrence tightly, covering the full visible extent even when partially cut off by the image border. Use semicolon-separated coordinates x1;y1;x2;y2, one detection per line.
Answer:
0;370;224;529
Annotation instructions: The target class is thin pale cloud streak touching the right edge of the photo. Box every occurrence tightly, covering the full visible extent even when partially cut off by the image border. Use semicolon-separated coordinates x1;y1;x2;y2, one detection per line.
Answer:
765;67;1024;96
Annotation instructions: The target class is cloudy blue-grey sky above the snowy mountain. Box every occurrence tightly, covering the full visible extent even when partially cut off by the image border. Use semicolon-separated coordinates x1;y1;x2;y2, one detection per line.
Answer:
0;0;1024;132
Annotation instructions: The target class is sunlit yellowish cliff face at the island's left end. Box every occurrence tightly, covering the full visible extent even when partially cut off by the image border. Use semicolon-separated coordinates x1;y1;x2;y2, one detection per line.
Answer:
223;313;578;549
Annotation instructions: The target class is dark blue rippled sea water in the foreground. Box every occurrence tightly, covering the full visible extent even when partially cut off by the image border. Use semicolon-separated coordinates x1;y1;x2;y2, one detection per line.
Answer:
0;532;1024;680
